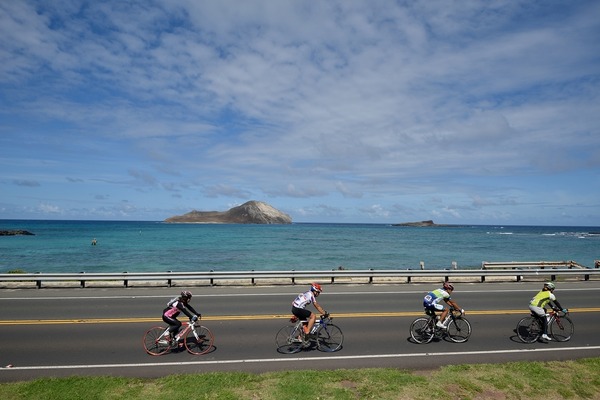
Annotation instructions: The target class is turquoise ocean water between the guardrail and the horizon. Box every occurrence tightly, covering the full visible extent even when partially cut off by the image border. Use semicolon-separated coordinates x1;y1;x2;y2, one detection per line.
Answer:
0;220;600;273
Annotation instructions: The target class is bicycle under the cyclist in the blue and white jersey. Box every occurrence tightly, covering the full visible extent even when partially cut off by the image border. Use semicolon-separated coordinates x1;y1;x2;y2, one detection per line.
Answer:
410;307;471;343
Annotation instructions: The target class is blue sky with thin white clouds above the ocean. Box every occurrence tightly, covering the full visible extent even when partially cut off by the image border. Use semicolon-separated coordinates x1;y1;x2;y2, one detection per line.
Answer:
0;0;600;226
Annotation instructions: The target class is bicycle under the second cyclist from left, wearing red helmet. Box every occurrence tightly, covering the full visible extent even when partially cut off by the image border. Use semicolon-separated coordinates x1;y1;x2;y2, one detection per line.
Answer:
275;314;344;354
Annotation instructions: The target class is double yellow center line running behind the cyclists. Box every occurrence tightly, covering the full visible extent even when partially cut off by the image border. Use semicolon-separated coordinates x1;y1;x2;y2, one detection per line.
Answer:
0;307;600;325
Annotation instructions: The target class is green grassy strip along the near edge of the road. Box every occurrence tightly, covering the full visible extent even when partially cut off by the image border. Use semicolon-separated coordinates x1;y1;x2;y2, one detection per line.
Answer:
0;358;600;400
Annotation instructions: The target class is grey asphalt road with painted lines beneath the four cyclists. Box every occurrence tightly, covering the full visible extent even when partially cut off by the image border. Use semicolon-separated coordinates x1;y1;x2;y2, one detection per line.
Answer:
0;281;600;382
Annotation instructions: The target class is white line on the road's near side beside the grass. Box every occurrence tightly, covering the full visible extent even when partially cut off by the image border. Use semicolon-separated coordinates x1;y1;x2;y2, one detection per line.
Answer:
0;346;600;372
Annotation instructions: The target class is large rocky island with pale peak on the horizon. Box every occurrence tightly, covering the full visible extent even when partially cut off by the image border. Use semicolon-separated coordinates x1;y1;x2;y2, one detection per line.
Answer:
165;200;292;224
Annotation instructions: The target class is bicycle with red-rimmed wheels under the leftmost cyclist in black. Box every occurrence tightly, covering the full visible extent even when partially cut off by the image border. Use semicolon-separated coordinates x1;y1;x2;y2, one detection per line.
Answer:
142;321;215;356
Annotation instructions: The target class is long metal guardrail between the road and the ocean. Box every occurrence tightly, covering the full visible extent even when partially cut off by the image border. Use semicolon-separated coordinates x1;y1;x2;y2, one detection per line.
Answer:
0;268;600;289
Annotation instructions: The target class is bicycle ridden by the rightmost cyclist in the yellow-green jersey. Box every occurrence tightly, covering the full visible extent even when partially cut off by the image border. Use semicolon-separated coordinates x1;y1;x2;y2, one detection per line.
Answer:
515;309;575;343
